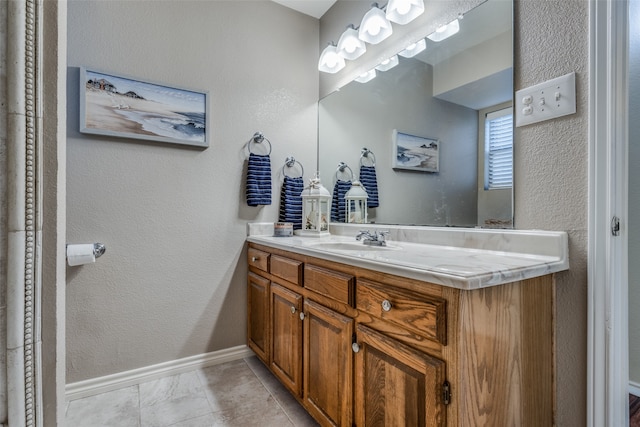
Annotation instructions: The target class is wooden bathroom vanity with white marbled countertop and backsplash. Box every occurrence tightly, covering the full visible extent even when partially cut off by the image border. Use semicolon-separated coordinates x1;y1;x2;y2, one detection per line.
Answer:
247;225;568;427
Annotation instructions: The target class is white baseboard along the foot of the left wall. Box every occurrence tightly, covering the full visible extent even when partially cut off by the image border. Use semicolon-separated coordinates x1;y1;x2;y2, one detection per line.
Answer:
65;345;254;402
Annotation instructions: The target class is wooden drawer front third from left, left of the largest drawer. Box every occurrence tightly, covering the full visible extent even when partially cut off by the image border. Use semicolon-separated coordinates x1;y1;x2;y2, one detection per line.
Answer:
304;264;355;307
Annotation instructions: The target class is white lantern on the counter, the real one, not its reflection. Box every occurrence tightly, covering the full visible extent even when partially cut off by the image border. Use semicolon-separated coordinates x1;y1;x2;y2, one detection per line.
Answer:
296;173;331;236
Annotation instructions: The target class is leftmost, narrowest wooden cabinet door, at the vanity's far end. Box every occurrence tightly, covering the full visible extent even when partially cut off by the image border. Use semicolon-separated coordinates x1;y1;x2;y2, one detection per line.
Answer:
247;272;269;364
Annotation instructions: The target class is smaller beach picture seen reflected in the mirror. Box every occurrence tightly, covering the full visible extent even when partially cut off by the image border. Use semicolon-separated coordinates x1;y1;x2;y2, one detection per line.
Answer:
392;129;440;172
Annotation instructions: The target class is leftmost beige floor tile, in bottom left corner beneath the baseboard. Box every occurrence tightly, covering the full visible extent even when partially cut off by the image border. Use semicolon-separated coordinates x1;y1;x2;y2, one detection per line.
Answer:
67;386;140;427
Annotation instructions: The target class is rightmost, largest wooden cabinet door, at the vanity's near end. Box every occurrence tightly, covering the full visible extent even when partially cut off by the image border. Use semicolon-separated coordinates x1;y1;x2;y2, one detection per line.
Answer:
354;325;446;427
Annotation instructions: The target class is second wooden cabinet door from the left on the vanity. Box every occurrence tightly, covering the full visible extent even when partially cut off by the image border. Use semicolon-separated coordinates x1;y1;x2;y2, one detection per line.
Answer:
271;283;302;396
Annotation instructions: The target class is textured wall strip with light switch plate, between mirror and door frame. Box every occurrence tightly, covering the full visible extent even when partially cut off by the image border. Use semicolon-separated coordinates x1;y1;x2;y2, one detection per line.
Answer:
514;0;589;426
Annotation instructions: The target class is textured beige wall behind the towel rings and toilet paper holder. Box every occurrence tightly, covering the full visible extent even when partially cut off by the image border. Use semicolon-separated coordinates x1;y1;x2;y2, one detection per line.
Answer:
67;1;318;383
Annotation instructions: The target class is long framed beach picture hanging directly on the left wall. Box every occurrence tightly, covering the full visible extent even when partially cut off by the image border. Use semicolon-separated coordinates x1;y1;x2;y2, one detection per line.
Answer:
80;67;209;148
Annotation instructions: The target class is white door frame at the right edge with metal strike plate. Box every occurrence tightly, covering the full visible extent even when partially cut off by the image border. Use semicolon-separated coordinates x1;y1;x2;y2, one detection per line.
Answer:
587;0;629;427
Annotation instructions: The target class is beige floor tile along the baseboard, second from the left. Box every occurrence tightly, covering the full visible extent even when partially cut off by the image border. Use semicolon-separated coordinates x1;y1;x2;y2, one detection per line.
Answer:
139;372;212;427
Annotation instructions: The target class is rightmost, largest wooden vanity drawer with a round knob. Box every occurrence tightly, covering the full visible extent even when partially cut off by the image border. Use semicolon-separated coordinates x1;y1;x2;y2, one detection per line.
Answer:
356;280;447;345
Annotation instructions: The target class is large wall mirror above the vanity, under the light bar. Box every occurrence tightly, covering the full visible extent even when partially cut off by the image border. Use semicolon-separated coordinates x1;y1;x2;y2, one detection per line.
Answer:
318;0;513;228
